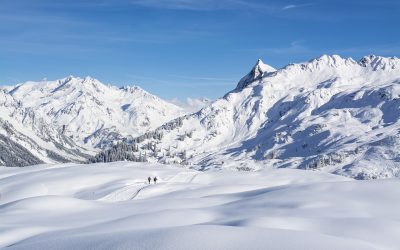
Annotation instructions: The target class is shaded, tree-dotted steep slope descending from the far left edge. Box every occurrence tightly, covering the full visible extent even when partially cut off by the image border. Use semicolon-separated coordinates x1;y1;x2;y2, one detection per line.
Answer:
0;90;89;166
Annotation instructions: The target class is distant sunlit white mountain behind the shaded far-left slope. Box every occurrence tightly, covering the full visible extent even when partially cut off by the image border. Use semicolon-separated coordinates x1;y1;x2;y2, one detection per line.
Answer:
9;76;183;148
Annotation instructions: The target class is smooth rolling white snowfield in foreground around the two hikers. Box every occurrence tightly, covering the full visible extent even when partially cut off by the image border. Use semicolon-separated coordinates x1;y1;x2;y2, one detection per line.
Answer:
0;162;400;250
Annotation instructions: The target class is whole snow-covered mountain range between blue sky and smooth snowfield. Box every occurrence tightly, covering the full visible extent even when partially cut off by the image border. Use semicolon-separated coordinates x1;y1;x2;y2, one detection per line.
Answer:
0;55;400;179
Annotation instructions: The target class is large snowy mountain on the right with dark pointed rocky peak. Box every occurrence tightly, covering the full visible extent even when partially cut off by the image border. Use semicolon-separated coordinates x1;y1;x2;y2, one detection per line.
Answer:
111;55;400;179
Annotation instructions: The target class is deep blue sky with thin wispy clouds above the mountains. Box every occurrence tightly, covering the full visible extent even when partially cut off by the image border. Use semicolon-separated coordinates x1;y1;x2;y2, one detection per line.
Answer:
0;0;400;99
